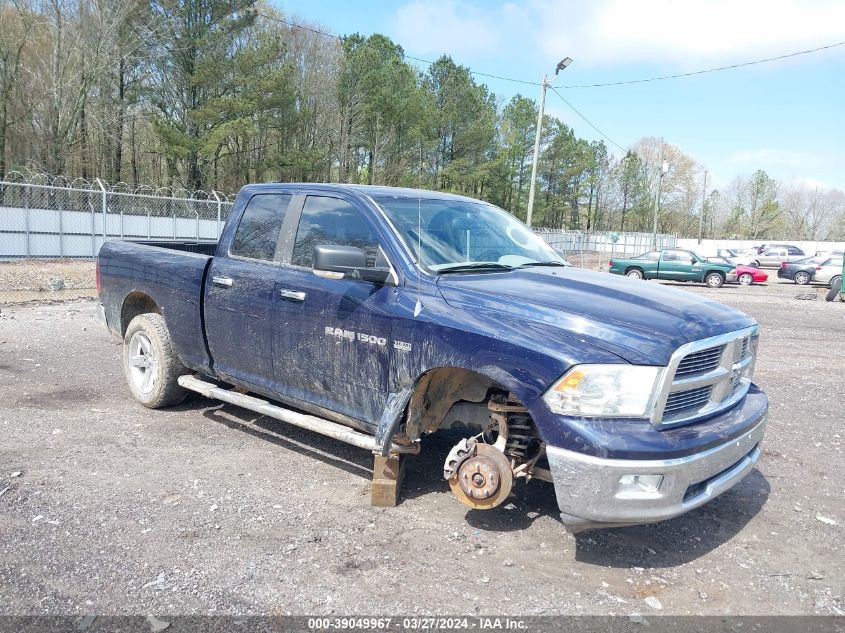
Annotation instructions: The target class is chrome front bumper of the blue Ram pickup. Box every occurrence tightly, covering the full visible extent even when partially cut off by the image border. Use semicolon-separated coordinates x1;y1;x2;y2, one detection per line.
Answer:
546;404;766;531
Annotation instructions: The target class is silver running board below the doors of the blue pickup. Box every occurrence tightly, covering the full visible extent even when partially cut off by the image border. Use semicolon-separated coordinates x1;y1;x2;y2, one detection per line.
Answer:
179;375;420;454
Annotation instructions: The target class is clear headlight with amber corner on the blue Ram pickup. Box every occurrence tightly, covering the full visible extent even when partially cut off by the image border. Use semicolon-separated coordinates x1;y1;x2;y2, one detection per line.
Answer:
543;365;660;418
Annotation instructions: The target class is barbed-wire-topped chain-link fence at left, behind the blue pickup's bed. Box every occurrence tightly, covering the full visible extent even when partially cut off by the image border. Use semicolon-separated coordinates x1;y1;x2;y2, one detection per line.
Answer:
0;173;232;304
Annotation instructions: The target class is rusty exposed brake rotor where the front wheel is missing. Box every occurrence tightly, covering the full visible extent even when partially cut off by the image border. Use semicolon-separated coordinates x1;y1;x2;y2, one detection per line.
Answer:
449;443;513;510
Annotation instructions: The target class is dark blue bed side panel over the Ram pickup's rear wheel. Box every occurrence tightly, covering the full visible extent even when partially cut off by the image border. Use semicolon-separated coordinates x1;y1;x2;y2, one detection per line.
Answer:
99;241;211;370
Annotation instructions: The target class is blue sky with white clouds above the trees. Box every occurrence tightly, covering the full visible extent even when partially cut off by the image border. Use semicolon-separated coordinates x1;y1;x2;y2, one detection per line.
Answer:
271;0;845;190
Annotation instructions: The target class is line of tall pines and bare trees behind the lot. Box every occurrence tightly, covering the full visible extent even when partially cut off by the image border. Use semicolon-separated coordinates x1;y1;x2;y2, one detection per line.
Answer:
0;0;845;239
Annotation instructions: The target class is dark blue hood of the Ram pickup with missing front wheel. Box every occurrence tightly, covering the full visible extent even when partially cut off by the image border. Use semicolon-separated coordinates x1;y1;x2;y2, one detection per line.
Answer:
437;267;755;365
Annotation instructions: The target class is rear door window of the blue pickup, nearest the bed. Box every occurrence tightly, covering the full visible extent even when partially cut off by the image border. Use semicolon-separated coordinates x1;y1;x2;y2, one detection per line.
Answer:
229;193;293;261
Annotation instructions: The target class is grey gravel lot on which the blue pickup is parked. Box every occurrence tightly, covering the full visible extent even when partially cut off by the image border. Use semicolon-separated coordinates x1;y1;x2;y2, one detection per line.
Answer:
0;282;845;615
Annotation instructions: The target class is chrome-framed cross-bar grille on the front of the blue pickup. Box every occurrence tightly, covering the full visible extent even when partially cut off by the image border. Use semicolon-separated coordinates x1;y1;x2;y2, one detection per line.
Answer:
652;326;757;428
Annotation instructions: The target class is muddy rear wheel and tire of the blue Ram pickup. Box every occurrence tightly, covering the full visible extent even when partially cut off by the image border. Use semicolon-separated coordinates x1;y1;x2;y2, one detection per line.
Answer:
123;312;189;409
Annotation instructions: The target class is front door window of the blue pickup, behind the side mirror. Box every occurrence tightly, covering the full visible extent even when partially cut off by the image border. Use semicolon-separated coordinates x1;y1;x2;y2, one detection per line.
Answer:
291;196;379;268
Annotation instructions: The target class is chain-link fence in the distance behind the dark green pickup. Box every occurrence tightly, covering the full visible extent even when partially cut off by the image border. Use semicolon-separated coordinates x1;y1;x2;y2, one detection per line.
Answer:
534;228;678;270
